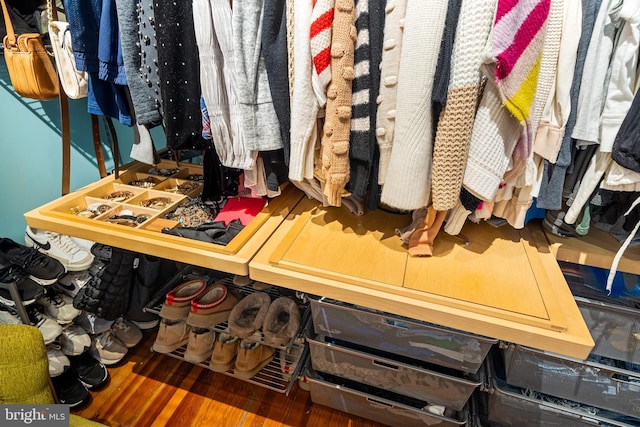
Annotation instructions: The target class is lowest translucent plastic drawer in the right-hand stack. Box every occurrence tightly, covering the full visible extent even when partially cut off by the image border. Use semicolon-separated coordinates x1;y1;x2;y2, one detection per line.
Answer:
483;379;640;427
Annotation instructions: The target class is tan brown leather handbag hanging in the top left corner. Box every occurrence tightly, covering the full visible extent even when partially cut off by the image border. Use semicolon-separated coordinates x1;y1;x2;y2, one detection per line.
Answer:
0;0;59;101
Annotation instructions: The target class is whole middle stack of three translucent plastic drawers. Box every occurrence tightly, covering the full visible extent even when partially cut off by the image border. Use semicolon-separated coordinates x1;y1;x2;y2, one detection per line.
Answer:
307;298;496;426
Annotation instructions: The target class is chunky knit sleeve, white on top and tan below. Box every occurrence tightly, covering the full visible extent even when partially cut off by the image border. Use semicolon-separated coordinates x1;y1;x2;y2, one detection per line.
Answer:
432;0;496;210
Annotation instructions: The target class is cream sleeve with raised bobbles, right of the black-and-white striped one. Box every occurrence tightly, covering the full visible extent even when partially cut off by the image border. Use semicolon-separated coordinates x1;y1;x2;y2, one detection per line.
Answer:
376;0;408;185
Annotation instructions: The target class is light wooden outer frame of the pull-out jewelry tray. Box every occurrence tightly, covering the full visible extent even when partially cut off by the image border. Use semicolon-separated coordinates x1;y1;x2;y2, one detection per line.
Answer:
25;162;302;275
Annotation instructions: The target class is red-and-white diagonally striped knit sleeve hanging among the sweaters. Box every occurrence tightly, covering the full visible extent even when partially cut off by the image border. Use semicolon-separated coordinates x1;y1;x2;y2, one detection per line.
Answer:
309;0;334;107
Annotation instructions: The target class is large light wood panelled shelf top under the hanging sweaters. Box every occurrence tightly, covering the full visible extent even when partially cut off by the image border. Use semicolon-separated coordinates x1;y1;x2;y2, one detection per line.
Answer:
249;199;594;358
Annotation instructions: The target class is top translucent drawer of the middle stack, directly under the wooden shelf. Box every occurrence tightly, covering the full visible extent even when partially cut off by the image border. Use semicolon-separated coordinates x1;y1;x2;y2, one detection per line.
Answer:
310;297;497;373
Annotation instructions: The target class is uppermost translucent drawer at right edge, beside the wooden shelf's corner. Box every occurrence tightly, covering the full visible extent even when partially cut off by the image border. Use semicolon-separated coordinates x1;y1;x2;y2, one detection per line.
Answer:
575;297;640;363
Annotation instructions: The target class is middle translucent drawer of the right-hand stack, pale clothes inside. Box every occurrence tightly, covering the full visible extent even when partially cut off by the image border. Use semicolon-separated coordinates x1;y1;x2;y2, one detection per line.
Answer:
504;345;640;418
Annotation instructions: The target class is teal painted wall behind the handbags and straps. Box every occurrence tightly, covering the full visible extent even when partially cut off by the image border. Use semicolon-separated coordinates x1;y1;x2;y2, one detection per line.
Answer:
0;61;165;244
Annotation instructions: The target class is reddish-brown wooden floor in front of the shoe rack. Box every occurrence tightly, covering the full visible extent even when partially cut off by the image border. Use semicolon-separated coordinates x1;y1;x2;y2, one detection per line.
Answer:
72;329;382;427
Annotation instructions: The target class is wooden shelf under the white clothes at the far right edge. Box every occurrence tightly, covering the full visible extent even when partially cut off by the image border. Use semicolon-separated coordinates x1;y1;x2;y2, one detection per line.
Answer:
544;227;640;274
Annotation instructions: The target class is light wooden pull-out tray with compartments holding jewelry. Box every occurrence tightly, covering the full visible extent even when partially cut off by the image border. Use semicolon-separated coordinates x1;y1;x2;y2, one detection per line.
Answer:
25;161;302;275
